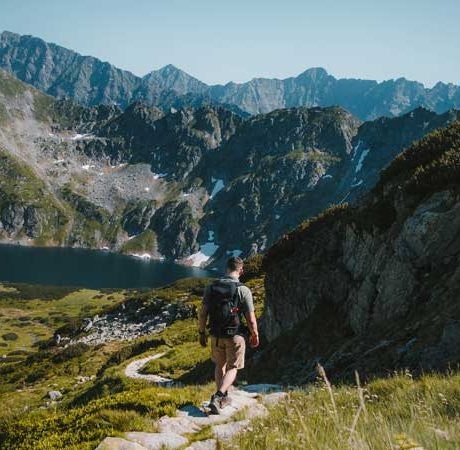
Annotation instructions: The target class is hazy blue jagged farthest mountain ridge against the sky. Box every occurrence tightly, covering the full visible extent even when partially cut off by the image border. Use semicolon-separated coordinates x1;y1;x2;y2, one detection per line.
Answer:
0;31;460;120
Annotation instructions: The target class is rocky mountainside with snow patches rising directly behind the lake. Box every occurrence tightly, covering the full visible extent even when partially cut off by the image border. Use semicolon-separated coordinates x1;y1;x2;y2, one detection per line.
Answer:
0;71;460;265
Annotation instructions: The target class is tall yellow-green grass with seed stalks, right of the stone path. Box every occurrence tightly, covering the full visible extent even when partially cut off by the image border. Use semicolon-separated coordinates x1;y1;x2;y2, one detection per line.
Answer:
224;373;460;450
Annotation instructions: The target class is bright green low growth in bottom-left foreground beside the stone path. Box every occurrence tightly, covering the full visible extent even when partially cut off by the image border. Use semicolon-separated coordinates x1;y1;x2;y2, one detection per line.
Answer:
0;383;209;450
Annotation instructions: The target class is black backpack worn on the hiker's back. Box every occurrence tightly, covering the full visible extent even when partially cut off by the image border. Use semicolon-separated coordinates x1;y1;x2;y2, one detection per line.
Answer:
208;280;243;338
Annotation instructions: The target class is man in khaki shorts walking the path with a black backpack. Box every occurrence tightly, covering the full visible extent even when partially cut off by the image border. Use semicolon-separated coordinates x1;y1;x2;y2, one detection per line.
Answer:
198;257;259;414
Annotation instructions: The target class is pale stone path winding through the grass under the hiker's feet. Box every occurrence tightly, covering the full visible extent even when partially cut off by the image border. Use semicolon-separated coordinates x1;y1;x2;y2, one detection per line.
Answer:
96;353;287;450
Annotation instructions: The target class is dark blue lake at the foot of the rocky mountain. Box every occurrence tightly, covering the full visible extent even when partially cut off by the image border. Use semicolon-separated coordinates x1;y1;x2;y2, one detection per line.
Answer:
0;245;212;288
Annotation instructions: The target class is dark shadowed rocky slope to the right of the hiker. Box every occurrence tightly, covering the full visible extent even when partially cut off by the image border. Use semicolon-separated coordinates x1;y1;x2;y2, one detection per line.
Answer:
257;121;460;383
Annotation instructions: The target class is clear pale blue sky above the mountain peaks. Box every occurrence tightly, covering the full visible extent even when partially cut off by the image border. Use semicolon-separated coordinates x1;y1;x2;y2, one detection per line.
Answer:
0;0;460;86
